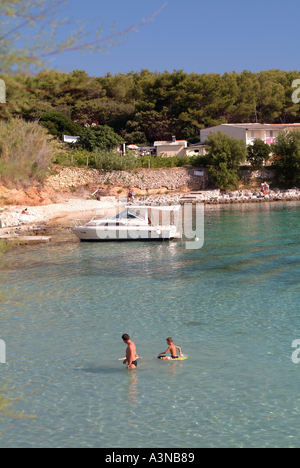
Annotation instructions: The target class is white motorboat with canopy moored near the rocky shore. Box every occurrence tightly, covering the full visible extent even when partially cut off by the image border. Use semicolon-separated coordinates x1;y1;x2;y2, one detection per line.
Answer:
72;205;181;241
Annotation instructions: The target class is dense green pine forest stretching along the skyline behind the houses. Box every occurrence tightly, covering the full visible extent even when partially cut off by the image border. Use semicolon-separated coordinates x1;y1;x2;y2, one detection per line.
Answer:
0;70;300;145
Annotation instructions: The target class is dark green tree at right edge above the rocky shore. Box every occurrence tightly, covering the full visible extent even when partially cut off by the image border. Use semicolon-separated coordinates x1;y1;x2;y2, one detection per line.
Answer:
272;130;300;187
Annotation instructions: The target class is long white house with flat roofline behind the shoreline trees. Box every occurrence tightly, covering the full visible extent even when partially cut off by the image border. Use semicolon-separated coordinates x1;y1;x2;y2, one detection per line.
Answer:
200;123;300;145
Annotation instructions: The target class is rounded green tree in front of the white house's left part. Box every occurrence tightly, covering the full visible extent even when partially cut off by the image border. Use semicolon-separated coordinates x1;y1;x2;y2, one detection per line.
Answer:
207;132;247;190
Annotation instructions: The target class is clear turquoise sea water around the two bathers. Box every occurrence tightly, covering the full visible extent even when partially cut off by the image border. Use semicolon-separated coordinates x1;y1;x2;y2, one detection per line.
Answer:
0;202;300;448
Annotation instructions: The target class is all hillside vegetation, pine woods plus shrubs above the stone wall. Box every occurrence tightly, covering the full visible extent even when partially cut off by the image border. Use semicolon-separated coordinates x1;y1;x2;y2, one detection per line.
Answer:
0;70;300;189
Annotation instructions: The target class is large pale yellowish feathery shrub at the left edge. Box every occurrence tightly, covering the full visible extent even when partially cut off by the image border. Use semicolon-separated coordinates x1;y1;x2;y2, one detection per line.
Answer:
0;119;57;184
